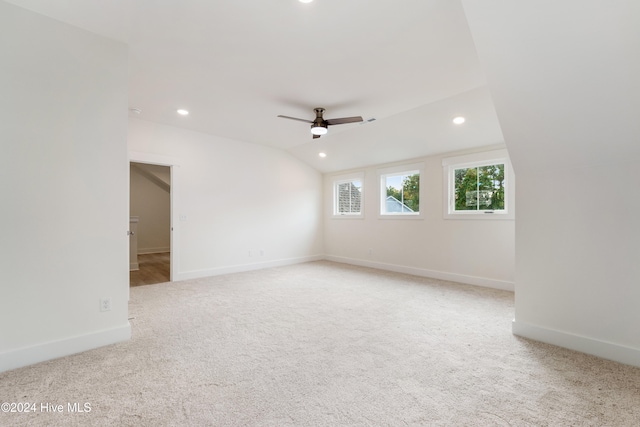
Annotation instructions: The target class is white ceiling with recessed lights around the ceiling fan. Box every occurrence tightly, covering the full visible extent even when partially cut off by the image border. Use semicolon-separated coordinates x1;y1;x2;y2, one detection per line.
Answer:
9;0;503;172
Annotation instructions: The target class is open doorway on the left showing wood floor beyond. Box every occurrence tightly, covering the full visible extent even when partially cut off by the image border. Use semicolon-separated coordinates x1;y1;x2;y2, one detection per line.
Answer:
129;161;172;287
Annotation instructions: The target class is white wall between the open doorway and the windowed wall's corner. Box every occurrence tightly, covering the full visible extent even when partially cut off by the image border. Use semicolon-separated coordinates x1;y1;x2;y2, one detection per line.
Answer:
129;118;323;280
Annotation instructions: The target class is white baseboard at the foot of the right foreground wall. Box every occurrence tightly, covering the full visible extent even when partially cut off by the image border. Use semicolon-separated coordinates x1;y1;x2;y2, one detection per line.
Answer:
511;320;640;367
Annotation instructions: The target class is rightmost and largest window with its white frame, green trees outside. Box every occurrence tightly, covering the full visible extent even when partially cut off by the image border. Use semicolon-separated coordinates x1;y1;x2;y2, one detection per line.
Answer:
442;150;514;219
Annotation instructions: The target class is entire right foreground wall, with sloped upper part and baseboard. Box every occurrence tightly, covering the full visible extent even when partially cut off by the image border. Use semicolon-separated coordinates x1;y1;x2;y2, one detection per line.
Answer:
463;0;640;366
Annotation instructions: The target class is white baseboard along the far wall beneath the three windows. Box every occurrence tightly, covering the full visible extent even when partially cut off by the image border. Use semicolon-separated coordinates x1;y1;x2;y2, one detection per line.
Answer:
324;255;515;292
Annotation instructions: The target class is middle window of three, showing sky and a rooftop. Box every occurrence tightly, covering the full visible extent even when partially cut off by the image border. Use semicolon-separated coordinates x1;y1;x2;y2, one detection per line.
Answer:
380;165;420;216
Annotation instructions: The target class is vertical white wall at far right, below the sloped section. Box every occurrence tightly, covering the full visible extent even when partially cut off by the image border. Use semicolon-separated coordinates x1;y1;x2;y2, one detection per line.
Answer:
516;162;640;350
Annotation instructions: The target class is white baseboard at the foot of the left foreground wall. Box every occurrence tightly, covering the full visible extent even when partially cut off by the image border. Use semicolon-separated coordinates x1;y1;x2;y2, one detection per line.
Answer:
0;322;131;372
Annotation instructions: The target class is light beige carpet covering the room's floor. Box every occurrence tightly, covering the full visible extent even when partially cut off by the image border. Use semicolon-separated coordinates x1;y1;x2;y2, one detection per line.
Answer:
0;262;640;426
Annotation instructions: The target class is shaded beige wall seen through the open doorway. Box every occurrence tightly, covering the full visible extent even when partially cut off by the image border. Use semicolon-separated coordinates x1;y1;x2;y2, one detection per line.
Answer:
129;165;171;254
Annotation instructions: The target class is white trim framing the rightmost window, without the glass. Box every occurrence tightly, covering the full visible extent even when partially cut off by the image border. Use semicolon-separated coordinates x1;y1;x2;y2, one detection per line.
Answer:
442;149;515;220
